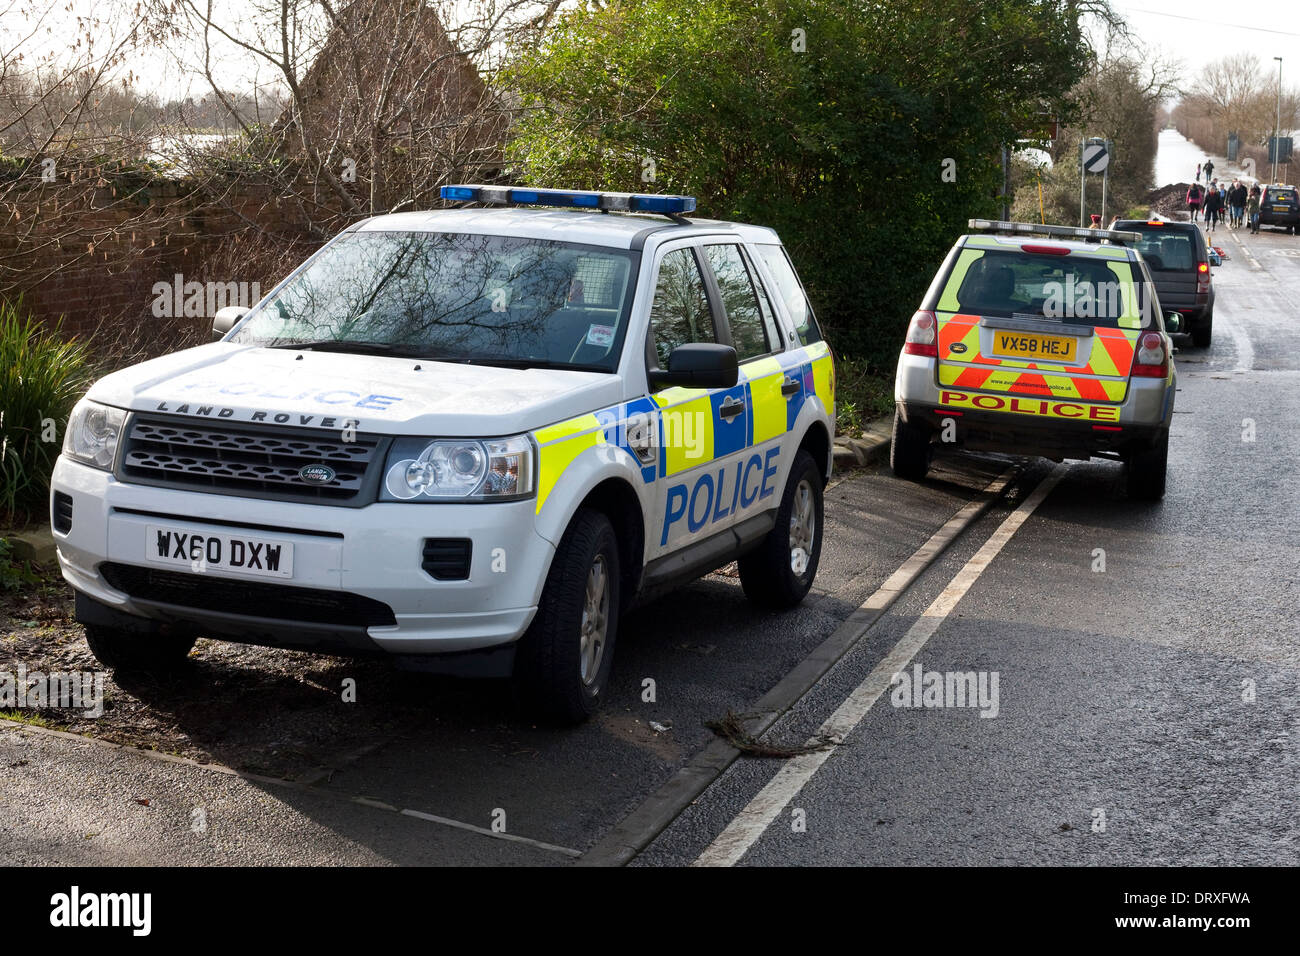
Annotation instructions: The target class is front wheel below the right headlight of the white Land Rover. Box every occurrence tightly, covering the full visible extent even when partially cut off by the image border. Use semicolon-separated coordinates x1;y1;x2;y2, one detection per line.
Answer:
514;509;620;724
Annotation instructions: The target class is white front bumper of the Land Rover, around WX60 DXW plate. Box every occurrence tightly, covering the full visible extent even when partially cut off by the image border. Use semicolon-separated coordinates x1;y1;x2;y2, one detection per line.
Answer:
51;457;555;656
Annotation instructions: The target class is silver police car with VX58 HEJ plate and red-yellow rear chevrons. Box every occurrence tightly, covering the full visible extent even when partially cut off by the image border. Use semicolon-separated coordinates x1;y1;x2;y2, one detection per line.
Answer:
891;220;1182;499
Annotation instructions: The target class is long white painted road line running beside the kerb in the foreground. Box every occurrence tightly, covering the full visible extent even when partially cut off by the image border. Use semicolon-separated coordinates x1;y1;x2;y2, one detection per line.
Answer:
694;464;1069;866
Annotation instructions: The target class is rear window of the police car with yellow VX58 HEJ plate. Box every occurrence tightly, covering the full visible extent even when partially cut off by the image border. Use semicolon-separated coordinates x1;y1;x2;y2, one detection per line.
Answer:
939;248;1143;329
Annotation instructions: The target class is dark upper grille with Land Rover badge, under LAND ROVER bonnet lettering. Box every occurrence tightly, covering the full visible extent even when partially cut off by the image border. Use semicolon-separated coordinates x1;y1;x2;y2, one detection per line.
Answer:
120;415;380;503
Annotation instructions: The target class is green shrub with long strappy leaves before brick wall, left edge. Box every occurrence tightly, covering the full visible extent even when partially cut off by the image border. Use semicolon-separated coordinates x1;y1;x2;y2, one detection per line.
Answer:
0;302;91;523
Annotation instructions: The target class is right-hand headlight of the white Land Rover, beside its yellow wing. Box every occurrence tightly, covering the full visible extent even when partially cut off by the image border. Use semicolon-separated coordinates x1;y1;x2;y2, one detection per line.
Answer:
384;434;536;501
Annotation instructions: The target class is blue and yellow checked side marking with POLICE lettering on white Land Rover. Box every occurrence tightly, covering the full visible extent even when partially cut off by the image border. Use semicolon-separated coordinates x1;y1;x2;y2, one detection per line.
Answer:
533;342;835;520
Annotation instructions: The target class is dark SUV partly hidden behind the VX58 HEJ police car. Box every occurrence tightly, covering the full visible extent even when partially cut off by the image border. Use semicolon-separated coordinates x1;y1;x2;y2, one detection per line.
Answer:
1110;219;1214;349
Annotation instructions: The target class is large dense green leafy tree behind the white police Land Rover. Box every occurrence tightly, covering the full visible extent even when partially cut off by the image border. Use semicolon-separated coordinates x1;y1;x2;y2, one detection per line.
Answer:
501;0;1088;364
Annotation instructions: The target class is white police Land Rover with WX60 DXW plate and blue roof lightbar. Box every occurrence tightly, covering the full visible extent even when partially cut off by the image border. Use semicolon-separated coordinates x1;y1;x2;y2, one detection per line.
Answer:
51;186;835;721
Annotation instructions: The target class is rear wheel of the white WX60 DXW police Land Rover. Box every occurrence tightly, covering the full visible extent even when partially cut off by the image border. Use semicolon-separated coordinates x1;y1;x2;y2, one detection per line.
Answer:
736;449;826;610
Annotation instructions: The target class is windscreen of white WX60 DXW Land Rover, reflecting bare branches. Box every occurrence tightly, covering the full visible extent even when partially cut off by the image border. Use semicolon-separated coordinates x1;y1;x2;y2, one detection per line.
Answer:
233;232;636;371
